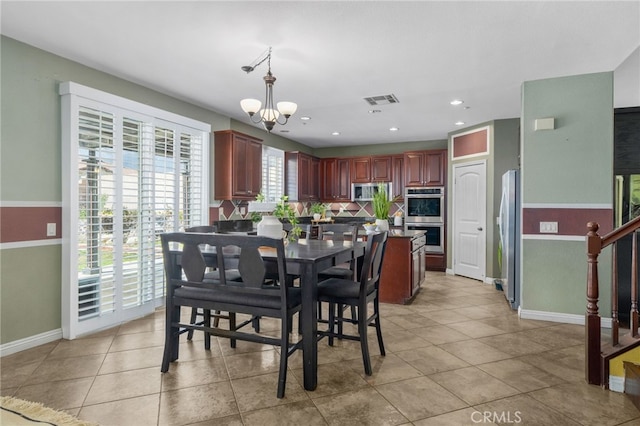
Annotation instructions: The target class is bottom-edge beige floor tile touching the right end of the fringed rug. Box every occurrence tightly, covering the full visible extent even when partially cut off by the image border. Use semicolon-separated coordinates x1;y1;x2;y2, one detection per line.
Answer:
78;393;160;426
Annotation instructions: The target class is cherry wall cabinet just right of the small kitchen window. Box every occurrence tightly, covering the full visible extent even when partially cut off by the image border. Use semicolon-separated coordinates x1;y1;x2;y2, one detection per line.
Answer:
284;151;320;201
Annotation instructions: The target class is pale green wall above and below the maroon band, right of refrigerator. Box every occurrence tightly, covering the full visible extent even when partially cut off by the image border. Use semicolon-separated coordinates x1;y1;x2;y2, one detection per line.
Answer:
521;72;613;315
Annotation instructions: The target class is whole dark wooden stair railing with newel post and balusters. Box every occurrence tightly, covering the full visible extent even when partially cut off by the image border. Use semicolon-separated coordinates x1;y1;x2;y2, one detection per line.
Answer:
585;217;640;385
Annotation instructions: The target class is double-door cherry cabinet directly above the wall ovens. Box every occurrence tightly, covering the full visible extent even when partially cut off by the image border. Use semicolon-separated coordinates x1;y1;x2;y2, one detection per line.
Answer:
404;149;447;186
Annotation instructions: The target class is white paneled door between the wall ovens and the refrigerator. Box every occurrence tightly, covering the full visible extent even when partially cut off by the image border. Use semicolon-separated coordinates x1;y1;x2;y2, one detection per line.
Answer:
453;161;487;281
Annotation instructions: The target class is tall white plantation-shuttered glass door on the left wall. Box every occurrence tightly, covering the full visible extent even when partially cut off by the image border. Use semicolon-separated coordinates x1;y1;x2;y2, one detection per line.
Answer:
60;83;210;339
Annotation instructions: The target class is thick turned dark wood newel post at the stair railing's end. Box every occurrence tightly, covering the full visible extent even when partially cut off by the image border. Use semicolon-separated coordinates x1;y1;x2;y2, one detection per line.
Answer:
585;222;602;385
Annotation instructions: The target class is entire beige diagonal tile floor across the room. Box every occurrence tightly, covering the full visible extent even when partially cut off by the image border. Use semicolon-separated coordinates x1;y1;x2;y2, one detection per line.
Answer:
0;273;640;426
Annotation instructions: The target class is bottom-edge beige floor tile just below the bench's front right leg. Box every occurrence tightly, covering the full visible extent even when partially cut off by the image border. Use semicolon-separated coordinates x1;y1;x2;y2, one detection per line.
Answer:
242;401;327;426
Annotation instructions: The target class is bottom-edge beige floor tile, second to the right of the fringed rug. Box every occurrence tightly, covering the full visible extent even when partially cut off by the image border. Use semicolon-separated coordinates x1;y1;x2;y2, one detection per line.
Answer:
158;382;238;425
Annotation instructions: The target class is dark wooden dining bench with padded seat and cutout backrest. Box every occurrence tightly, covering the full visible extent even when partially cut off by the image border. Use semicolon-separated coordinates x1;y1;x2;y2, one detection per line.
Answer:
160;233;302;398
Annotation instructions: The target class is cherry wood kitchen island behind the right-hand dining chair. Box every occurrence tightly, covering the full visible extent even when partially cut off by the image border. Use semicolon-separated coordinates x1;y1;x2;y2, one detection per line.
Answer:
379;228;426;304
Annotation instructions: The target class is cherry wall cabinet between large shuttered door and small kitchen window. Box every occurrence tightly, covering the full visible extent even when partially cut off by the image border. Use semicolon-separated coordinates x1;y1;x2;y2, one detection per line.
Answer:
214;130;262;200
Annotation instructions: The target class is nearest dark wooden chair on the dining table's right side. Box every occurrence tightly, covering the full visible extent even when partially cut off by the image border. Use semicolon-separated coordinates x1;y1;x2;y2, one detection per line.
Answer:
318;232;387;376
